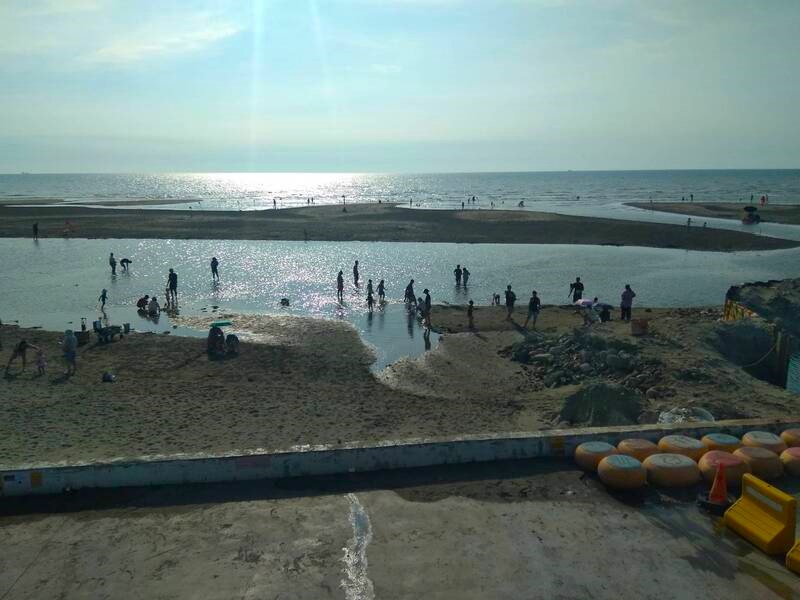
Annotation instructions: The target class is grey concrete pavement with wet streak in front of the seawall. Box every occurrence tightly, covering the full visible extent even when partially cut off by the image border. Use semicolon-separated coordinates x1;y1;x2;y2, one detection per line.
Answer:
0;460;800;600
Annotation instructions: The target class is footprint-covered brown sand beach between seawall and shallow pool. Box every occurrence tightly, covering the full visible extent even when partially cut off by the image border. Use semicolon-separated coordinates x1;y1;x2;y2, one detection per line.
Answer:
0;306;796;466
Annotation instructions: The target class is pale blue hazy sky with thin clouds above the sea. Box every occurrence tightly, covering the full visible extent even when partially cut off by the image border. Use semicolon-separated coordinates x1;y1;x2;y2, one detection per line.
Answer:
0;0;800;173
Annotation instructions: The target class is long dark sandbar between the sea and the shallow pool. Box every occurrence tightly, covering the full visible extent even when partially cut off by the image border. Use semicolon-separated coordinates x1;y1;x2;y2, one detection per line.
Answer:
0;204;800;251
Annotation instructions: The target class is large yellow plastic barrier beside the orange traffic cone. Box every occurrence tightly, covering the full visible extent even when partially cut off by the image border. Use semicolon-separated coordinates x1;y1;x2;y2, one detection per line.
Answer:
725;473;797;554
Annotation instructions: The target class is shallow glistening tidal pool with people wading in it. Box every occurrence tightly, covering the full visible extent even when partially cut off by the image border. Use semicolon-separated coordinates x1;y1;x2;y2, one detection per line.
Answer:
0;239;800;368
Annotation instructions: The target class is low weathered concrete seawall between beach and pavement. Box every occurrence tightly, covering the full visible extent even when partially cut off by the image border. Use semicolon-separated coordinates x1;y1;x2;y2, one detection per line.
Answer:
0;417;800;496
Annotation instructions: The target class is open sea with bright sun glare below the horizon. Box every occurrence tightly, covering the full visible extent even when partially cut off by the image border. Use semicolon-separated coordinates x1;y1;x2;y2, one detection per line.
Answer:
0;170;800;212
